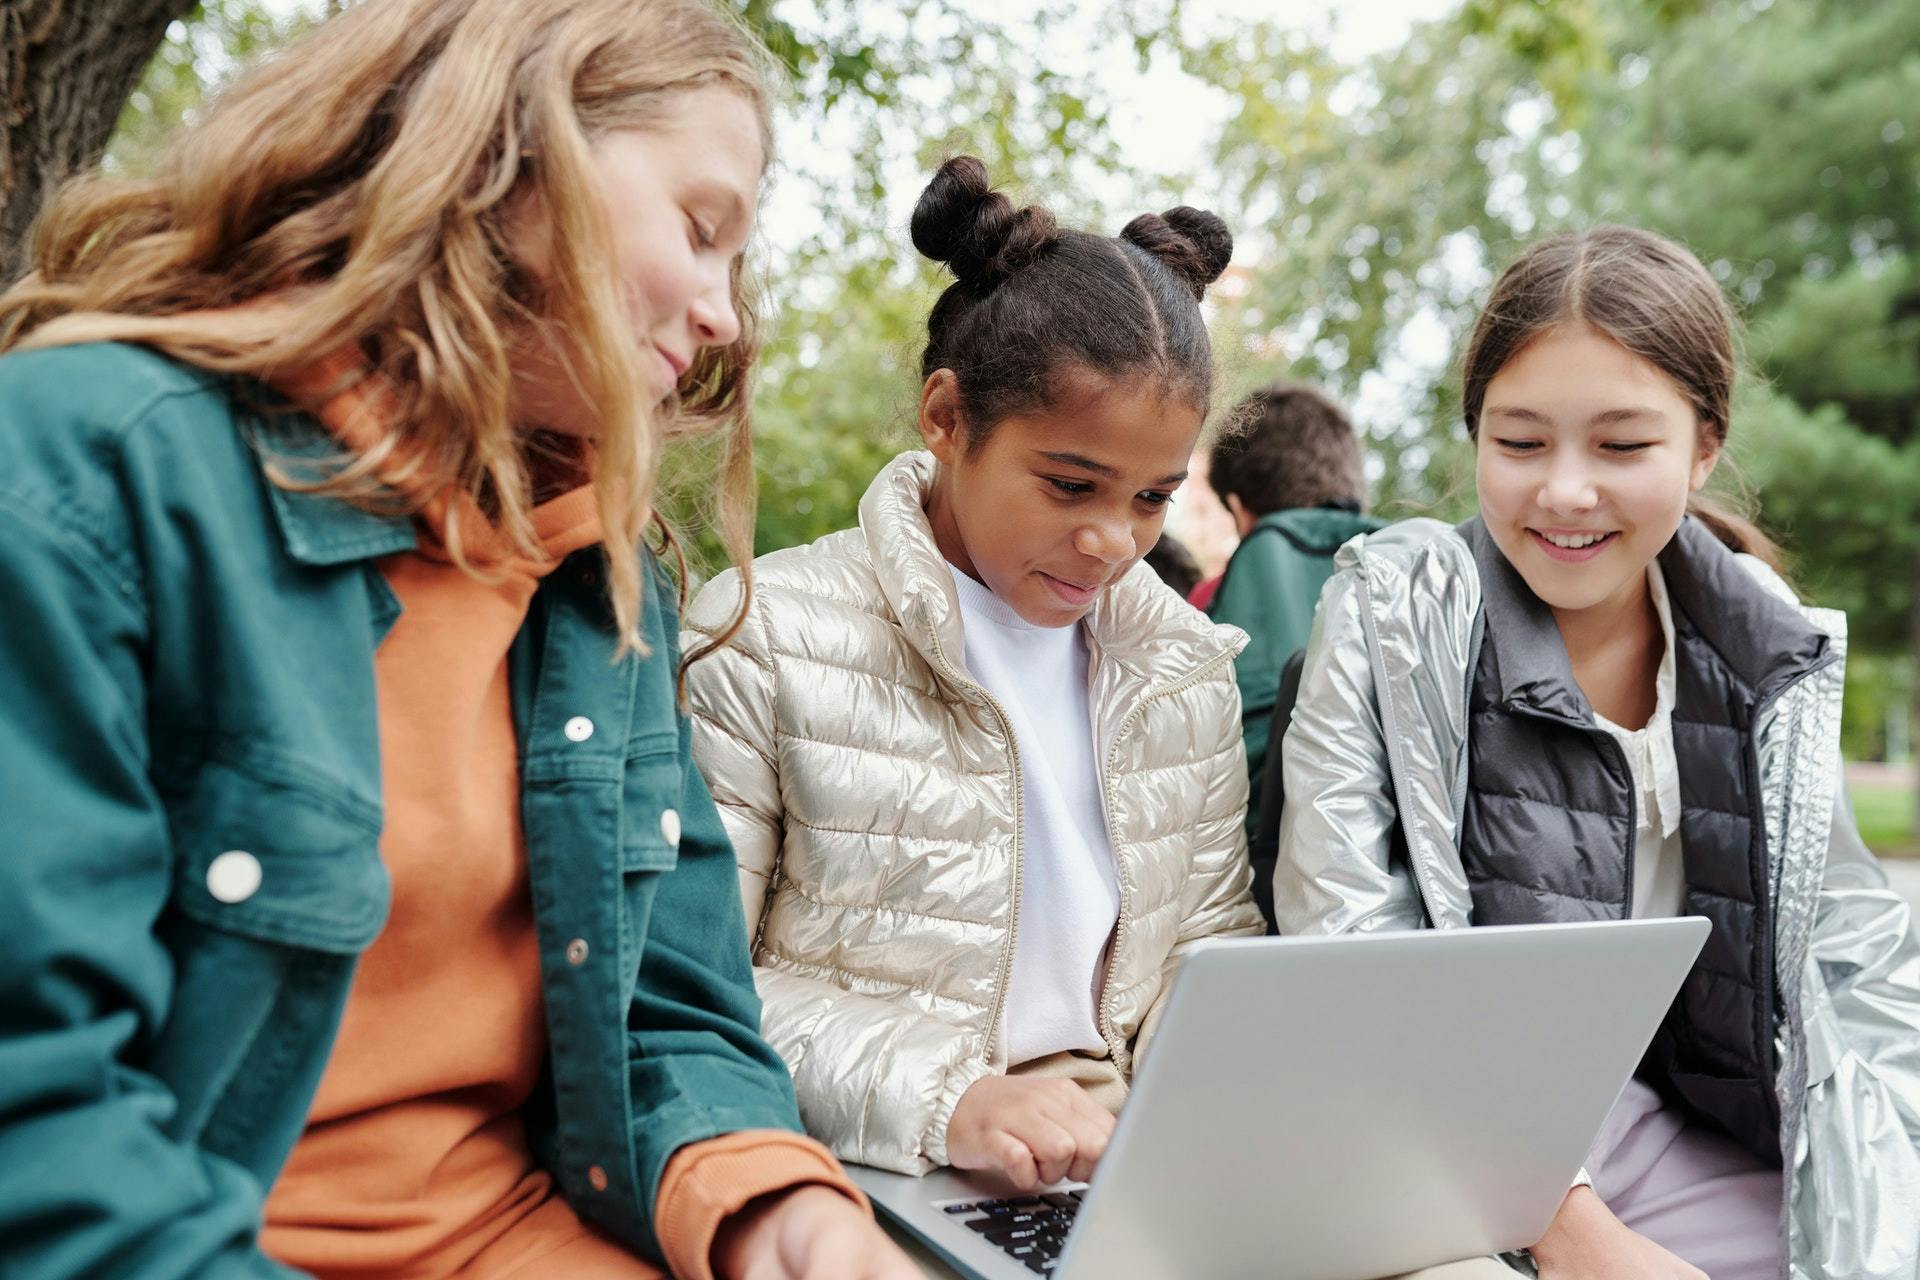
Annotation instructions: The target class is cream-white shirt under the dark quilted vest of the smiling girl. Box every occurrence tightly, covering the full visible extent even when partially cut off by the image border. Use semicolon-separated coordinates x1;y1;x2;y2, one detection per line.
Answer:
1594;560;1686;919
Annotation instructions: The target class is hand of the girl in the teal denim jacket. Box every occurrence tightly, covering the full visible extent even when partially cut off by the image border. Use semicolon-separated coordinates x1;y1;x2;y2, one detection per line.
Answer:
712;1186;922;1280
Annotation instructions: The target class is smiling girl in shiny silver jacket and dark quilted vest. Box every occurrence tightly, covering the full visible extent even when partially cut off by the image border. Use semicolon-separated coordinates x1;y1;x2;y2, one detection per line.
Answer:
1273;226;1920;1280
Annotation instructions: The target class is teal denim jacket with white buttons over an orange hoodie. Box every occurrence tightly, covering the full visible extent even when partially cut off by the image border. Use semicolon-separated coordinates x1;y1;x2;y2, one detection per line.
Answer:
0;345;799;1280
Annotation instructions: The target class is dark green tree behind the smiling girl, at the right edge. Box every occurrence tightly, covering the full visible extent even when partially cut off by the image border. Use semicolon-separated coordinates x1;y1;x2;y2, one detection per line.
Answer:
1572;0;1920;652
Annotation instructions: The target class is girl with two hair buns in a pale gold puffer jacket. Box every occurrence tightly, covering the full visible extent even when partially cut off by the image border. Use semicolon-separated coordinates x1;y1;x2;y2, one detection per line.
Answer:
687;157;1261;1188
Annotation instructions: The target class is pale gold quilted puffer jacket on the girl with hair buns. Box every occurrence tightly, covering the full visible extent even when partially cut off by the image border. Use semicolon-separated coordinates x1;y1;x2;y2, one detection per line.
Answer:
685;453;1261;1173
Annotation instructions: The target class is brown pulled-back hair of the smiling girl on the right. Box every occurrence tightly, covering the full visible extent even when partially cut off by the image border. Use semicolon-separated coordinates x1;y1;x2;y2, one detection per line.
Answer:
1461;226;1780;570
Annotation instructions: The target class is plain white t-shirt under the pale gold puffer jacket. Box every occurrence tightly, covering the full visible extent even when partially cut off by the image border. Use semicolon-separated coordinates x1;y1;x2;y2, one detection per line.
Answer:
948;566;1119;1067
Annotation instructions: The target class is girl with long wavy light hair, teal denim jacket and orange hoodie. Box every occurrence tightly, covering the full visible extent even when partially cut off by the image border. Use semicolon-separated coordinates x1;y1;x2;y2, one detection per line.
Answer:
0;0;918;1280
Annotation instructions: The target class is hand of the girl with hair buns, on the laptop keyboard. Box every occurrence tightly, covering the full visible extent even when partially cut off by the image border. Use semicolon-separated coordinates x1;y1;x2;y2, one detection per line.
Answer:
947;1075;1114;1192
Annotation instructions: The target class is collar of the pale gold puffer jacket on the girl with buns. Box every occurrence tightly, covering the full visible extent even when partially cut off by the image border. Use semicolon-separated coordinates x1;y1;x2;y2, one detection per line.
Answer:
860;451;1246;697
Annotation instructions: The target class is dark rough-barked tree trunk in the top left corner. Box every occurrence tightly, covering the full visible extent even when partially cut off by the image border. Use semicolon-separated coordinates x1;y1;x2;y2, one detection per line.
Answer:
0;0;196;284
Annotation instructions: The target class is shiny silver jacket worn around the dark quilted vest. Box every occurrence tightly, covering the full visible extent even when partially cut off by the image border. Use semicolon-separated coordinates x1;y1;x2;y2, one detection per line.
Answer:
1273;520;1920;1280
